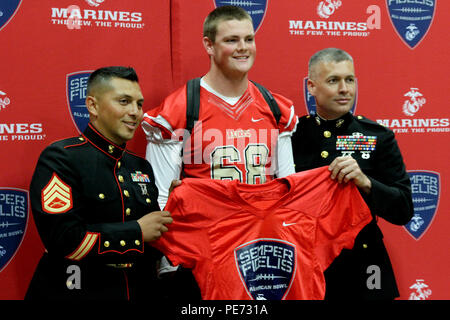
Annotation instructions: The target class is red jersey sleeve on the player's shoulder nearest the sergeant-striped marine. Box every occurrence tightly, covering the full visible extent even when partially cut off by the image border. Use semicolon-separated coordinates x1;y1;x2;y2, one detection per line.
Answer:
142;85;186;139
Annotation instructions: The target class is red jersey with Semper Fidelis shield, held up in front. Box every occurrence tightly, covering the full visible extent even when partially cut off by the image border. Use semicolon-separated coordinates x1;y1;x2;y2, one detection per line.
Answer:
153;167;371;300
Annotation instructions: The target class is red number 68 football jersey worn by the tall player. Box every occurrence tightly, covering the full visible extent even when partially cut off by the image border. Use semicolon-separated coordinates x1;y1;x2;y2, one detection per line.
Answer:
143;81;297;184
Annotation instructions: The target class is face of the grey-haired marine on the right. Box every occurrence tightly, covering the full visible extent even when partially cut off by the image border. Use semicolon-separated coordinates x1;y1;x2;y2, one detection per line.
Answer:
307;60;356;120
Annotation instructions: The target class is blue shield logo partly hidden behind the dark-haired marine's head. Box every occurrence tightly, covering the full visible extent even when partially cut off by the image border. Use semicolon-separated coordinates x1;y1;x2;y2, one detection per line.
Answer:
66;70;92;133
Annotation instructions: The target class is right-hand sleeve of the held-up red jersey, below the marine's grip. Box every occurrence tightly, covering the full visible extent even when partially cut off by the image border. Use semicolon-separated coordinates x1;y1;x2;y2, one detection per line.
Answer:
315;179;372;270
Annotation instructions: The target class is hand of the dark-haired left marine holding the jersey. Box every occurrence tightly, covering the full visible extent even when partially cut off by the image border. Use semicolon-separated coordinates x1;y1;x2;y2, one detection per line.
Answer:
137;211;173;242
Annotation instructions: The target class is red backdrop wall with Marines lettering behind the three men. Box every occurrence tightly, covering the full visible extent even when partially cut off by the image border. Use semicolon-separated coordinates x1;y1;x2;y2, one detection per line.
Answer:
0;0;450;299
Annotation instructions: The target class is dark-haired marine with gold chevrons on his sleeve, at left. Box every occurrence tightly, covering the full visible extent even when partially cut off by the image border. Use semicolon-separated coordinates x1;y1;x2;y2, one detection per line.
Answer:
26;67;171;301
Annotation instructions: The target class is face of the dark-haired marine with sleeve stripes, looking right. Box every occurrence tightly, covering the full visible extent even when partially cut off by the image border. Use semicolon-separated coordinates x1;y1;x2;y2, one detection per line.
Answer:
86;78;144;145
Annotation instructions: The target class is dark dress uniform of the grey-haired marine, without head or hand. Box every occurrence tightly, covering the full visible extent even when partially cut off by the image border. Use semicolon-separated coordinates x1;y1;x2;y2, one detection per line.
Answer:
292;112;413;300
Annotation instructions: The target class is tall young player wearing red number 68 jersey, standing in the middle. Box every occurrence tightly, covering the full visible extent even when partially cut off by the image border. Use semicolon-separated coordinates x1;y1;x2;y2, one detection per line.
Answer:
142;6;297;208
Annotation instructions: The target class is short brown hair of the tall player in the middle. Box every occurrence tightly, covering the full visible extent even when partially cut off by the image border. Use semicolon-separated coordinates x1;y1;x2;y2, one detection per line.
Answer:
203;6;253;42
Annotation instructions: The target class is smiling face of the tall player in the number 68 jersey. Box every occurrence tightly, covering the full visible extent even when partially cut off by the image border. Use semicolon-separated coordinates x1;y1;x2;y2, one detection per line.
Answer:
203;19;256;77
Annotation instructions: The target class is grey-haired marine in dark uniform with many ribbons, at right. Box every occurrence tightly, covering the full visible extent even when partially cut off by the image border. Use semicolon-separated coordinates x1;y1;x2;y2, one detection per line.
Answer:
292;48;413;300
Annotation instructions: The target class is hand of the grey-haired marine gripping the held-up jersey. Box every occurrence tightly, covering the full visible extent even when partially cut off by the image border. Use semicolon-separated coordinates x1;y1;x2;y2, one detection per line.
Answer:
328;156;372;194
